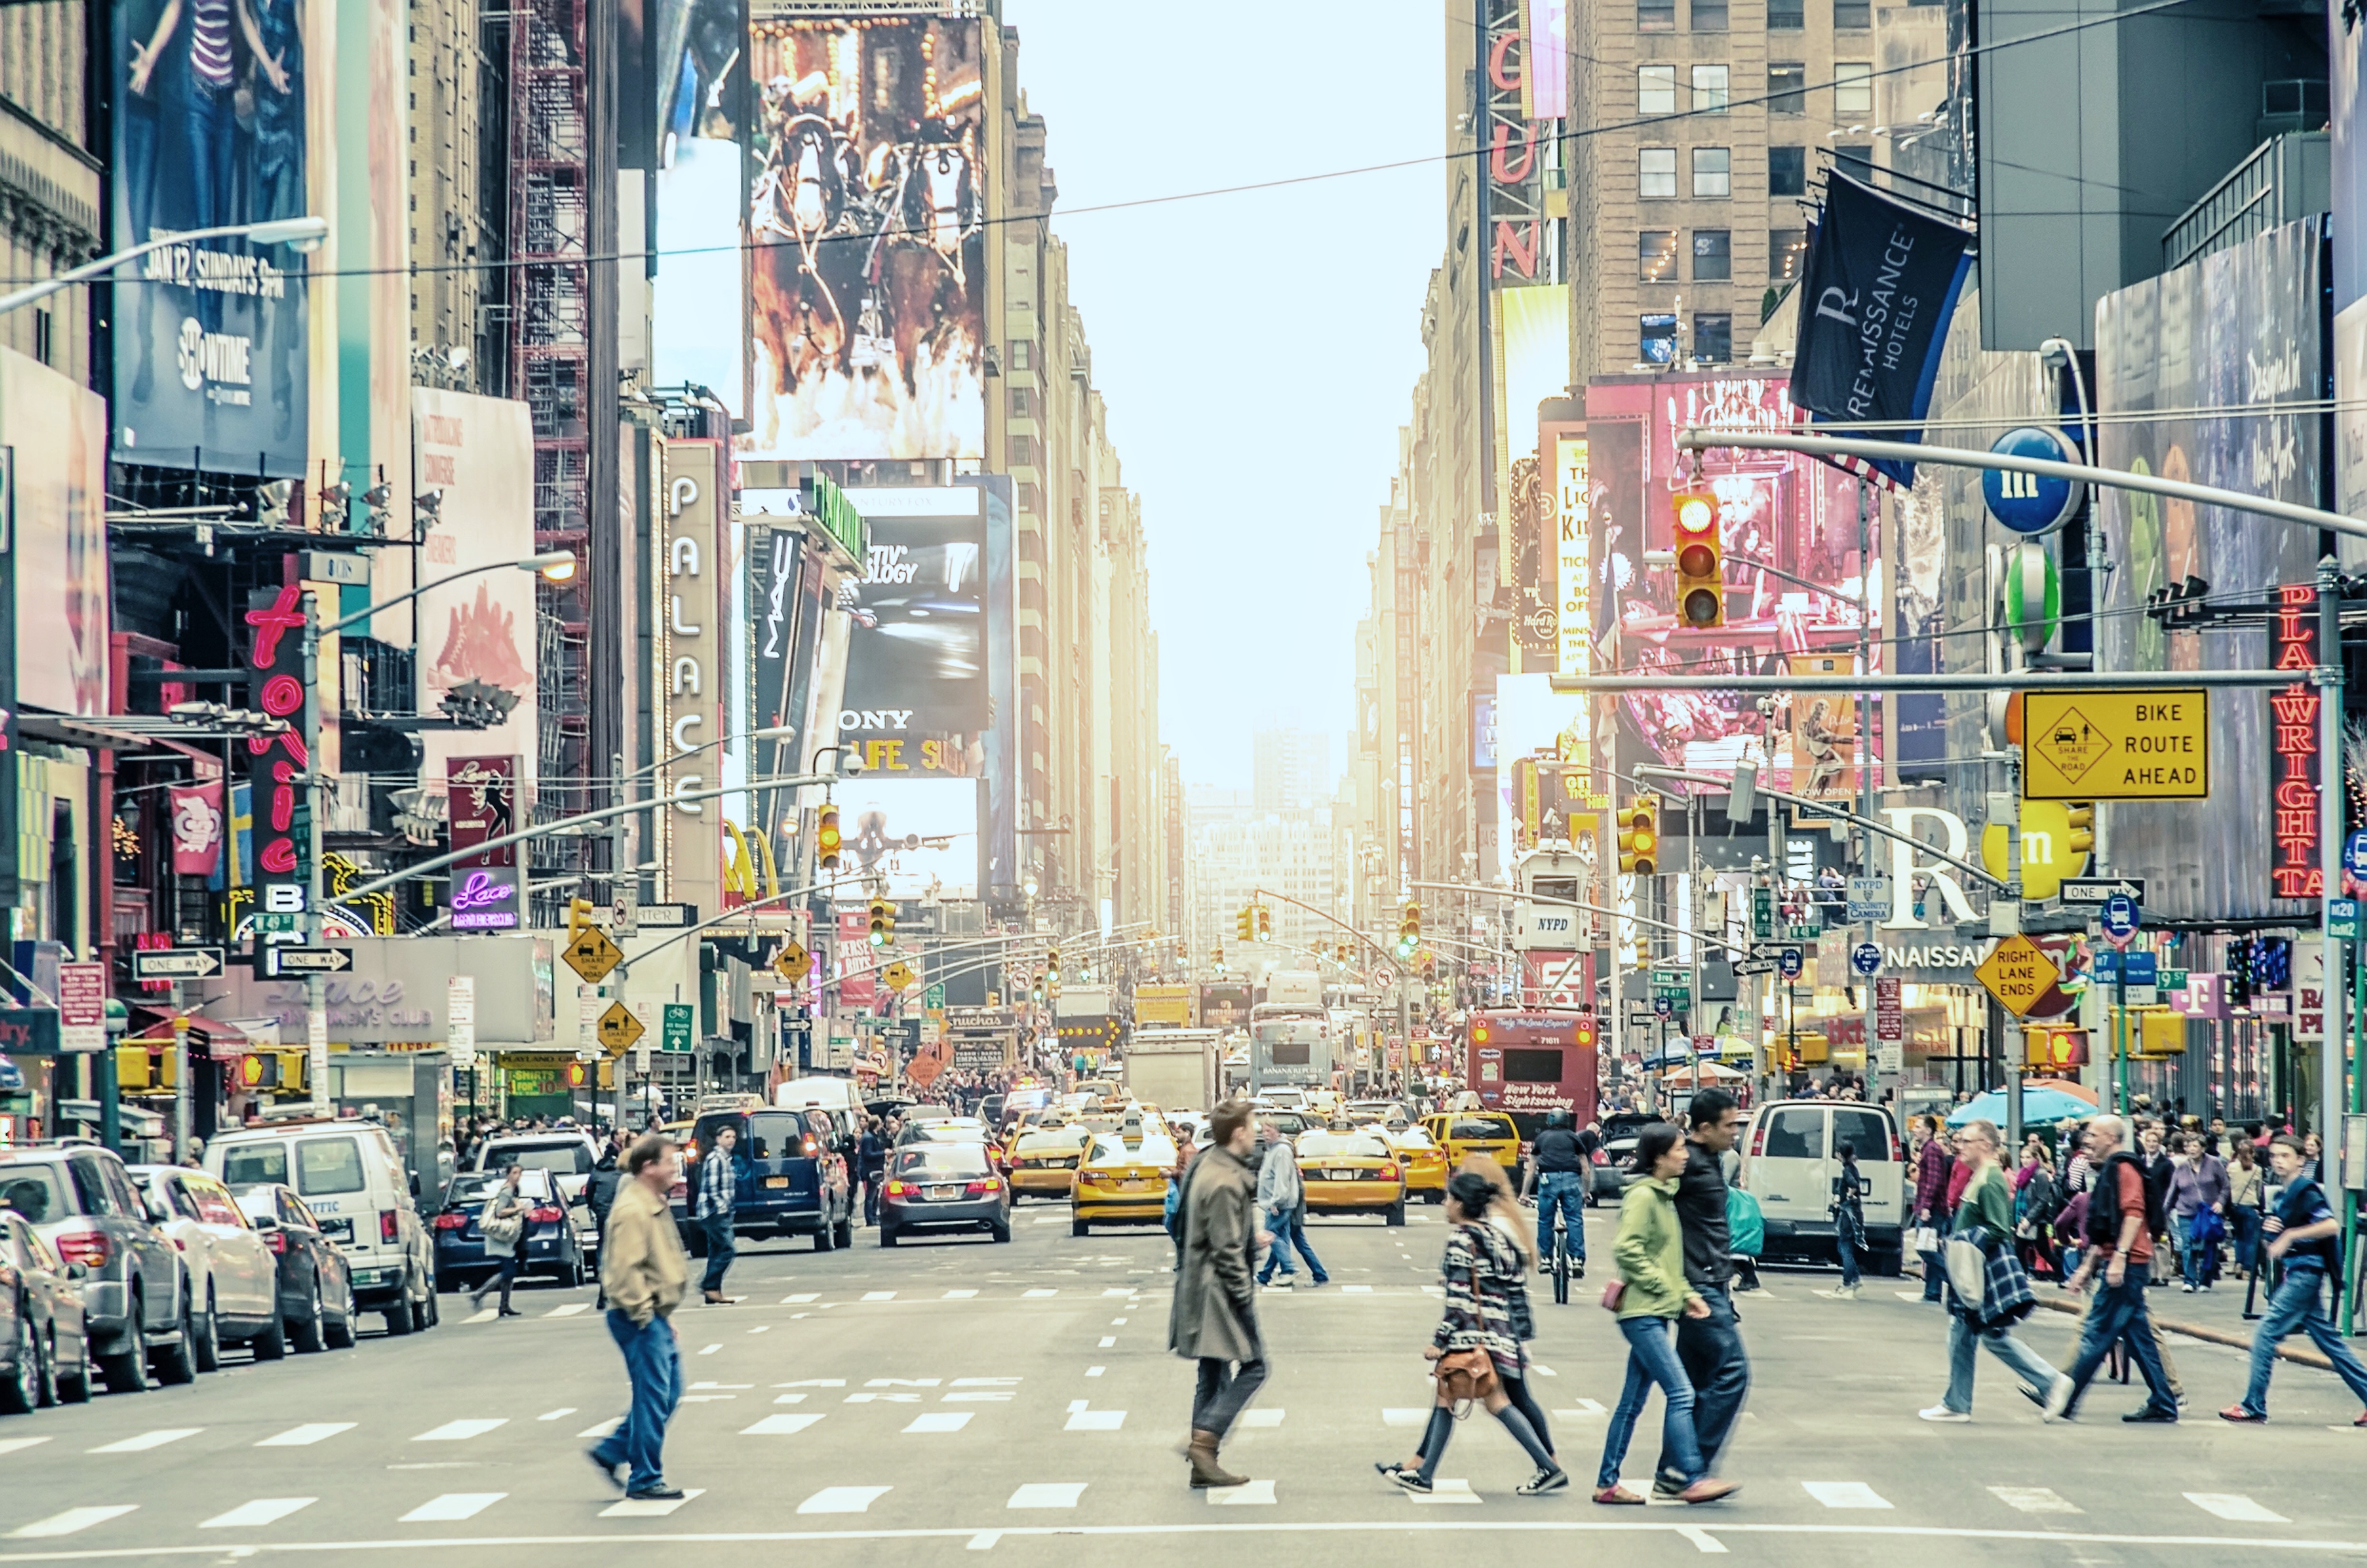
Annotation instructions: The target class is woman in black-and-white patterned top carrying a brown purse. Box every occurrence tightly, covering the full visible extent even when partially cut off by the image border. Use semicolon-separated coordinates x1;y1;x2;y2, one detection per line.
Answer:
1373;1170;1569;1497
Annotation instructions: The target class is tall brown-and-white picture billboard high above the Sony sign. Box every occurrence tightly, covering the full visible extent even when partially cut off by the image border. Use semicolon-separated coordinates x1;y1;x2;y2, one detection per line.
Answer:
739;17;987;460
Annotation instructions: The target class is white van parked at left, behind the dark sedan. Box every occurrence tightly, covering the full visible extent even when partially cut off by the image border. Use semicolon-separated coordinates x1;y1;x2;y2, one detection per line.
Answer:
206;1118;436;1333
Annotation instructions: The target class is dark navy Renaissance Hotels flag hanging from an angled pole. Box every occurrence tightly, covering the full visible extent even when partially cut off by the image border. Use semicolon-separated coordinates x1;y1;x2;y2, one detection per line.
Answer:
1792;170;1972;490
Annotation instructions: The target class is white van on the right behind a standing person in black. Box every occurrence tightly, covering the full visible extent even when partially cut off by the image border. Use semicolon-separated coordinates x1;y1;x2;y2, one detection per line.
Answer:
1735;1099;1908;1274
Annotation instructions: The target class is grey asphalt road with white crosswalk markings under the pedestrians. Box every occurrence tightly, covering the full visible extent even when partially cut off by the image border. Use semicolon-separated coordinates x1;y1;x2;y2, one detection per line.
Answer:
0;1205;2367;1568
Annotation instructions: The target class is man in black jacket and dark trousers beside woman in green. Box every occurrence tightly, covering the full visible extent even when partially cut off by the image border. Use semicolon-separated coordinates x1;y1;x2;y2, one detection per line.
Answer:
1652;1089;1751;1497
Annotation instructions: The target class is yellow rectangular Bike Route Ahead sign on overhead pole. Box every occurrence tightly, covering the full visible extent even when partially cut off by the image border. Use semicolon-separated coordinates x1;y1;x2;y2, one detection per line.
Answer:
2022;687;2211;801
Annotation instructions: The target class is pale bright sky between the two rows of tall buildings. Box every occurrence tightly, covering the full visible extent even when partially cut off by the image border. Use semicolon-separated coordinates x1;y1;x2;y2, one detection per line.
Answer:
1004;0;1446;789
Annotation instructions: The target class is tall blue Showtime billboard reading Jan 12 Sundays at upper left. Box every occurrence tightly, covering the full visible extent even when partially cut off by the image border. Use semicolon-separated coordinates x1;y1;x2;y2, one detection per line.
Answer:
109;0;313;479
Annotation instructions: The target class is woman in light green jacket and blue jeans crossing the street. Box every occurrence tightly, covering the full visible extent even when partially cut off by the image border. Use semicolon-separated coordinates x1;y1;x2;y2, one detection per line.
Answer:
1595;1123;1735;1504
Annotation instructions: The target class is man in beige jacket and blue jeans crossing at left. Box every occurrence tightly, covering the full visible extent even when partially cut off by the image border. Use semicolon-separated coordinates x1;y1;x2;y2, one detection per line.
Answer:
592;1132;691;1499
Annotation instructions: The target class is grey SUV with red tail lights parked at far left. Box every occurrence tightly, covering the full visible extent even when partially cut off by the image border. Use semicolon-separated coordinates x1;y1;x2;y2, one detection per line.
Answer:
0;1142;196;1393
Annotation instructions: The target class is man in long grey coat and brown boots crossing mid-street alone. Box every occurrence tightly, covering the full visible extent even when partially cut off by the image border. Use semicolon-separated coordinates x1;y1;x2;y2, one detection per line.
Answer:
1167;1099;1266;1488
